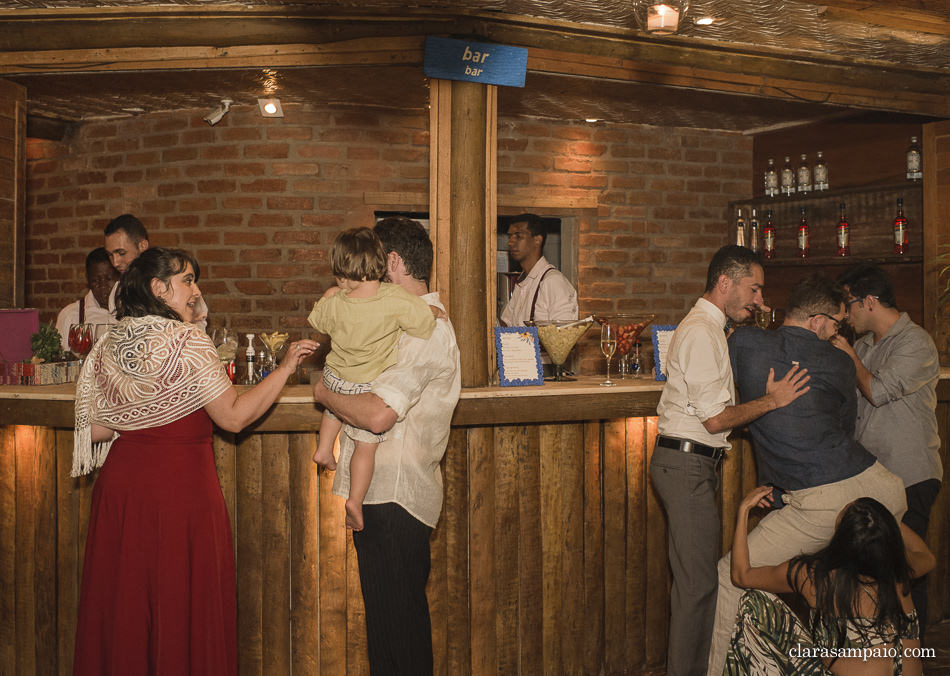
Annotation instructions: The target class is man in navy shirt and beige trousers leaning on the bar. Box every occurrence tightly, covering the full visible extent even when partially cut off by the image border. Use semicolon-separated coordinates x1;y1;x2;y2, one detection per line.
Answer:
709;275;907;676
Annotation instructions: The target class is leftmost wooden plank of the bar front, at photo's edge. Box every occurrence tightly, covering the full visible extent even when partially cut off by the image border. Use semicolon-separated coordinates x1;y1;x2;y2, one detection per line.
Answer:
0;425;19;674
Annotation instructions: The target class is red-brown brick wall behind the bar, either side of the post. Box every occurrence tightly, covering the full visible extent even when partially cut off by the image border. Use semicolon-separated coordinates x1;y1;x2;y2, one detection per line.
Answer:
26;105;752;372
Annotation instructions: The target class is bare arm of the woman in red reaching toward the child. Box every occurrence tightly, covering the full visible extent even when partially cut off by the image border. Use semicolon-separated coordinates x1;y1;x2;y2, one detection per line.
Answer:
205;339;320;432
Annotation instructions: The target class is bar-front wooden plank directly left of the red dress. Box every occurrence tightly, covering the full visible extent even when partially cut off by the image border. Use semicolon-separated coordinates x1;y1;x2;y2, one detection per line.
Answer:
55;430;83;676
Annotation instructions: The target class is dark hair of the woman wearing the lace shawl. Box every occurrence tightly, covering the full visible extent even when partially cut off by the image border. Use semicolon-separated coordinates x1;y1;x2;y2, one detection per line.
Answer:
115;247;200;321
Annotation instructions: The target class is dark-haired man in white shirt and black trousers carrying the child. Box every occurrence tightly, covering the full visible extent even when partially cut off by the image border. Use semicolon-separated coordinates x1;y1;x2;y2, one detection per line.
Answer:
313;217;461;676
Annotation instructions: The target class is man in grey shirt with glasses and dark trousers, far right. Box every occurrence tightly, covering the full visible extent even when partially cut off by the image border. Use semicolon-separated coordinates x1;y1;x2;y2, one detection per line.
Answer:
834;265;943;634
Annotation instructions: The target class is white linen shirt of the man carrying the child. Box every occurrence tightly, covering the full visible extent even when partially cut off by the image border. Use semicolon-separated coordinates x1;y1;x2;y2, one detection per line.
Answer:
333;293;461;528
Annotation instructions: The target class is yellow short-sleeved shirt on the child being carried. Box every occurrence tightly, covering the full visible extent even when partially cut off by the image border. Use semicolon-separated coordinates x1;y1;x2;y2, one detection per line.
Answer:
307;282;435;383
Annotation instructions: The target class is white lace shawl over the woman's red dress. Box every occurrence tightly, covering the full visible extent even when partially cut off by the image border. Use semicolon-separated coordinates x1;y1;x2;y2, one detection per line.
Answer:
72;316;231;477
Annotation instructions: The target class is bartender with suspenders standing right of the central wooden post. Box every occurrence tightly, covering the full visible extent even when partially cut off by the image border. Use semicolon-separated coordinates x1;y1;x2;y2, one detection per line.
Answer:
501;214;577;326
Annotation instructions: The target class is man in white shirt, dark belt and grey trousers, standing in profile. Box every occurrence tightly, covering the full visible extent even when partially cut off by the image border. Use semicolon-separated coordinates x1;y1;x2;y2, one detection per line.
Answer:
650;245;808;676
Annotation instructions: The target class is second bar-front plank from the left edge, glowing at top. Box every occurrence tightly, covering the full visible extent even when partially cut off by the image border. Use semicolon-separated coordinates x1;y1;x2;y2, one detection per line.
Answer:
15;426;38;674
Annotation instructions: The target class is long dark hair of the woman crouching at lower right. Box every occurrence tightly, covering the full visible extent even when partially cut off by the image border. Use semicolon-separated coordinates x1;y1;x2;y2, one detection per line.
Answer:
788;498;911;647
